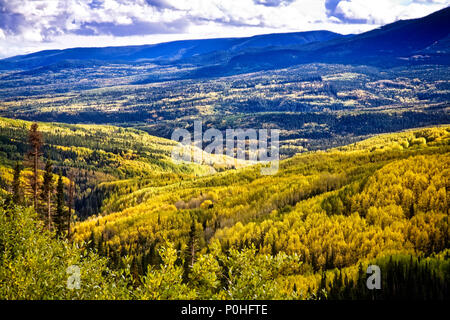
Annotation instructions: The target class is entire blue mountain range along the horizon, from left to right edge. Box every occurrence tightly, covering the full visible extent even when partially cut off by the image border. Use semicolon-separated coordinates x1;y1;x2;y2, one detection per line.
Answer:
0;7;450;78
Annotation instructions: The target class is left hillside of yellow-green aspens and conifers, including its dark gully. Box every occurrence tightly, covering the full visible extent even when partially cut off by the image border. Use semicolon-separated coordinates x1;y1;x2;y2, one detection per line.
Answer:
0;118;215;217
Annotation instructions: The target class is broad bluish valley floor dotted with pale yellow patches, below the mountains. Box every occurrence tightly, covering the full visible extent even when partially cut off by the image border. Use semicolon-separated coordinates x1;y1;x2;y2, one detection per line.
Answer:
0;64;450;157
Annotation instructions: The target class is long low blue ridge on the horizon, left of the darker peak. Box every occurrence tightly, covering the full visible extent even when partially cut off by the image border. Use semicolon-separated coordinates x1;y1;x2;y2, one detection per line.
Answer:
0;31;342;69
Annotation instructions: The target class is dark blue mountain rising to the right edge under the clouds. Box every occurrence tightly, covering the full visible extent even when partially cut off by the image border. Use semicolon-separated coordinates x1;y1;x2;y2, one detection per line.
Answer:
192;7;450;77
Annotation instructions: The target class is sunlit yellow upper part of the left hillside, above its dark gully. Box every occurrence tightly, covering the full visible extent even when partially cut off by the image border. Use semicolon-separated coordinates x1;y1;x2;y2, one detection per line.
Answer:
0;118;204;172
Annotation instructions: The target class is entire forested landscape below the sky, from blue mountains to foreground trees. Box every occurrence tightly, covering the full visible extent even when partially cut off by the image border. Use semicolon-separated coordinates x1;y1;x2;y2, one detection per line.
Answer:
0;8;450;300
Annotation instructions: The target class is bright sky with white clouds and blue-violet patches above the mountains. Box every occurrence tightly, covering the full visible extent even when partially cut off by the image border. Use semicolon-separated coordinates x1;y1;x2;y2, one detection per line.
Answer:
0;0;450;58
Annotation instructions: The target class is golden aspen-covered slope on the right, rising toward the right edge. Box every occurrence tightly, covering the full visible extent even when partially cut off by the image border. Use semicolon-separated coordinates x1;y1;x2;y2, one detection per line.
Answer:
75;127;450;271
